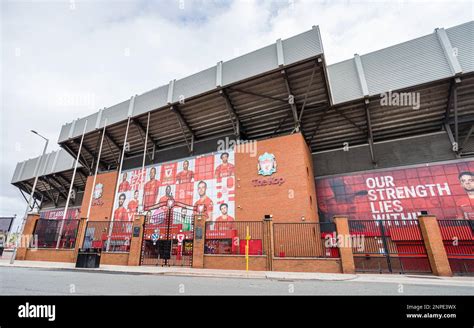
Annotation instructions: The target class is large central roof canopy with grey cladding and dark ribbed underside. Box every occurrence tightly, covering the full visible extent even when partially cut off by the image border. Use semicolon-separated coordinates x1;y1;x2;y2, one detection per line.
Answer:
59;26;331;170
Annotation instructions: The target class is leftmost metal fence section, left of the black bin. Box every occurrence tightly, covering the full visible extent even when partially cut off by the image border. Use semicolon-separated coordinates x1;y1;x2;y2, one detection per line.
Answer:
33;219;79;249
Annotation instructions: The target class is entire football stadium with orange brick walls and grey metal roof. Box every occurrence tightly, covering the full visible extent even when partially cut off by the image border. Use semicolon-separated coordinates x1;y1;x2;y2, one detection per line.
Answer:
8;22;474;275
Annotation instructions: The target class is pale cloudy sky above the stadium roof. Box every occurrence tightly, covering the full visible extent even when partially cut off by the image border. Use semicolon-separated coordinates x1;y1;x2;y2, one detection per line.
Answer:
0;0;474;228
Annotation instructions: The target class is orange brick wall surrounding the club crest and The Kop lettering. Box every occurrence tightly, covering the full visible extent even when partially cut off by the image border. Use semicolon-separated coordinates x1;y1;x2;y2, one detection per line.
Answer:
235;133;318;222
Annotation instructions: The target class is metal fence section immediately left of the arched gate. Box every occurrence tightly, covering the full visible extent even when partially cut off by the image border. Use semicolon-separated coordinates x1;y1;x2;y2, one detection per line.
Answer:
82;221;133;252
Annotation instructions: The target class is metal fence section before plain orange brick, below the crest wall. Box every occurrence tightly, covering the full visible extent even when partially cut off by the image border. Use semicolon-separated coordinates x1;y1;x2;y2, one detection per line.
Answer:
273;222;339;258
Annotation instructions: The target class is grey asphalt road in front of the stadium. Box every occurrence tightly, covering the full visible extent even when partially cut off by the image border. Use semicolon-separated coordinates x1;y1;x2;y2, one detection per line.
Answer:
0;267;474;295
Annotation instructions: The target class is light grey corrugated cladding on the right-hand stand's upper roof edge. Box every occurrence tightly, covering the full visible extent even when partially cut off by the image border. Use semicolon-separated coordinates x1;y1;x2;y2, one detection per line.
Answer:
328;22;474;104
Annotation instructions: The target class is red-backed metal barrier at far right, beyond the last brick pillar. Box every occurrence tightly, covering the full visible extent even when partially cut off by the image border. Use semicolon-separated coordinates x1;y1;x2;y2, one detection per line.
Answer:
438;219;474;275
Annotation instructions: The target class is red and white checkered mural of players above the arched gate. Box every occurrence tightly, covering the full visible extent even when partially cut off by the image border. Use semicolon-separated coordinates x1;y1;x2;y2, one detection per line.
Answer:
113;151;235;222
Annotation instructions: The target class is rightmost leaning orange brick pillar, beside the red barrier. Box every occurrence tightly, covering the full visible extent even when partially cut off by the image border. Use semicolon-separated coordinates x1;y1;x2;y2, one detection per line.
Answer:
418;215;453;277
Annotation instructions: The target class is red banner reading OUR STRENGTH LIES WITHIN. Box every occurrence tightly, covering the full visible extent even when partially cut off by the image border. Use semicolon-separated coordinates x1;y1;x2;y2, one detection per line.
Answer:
316;161;474;221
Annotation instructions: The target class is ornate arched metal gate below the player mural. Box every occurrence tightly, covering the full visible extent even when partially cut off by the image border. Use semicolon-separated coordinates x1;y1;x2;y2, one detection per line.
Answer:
140;199;194;267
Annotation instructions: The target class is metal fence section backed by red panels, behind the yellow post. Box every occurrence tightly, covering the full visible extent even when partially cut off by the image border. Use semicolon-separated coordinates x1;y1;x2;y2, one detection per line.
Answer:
204;221;265;255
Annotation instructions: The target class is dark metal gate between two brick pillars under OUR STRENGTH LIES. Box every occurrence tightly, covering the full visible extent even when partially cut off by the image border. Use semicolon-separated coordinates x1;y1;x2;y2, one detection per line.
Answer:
349;220;431;273
